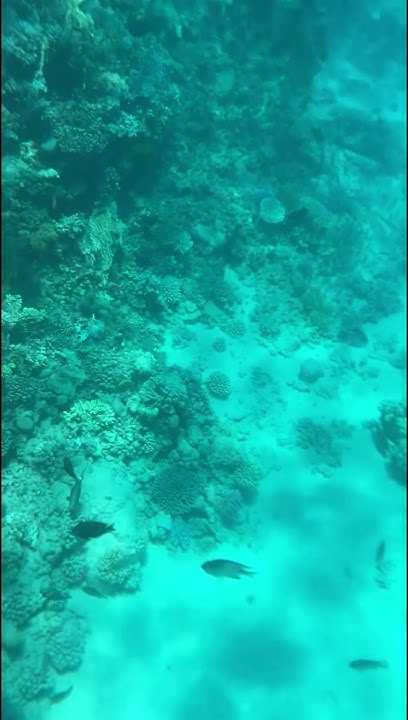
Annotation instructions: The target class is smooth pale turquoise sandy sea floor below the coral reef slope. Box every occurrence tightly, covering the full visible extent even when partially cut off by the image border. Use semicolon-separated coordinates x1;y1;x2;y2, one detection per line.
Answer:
48;310;406;720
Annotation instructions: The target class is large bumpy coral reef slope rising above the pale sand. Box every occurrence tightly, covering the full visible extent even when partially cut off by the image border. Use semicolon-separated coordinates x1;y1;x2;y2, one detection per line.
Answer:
1;0;406;718
